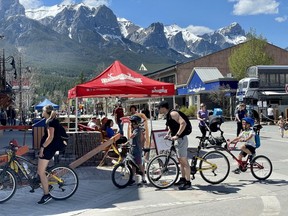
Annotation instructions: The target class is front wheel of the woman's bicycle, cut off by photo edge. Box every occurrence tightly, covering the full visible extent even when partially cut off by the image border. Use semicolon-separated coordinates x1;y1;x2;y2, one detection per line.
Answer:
0;169;17;203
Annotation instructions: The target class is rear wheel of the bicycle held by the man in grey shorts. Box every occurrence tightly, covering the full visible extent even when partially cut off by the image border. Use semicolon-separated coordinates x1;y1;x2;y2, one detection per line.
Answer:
199;151;230;184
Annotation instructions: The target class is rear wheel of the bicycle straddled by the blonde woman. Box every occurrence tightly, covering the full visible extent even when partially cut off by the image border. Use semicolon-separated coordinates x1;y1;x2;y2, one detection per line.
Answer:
47;166;79;200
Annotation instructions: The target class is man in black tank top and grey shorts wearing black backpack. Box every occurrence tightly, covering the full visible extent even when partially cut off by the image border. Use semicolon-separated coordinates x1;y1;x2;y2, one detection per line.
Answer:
158;101;192;190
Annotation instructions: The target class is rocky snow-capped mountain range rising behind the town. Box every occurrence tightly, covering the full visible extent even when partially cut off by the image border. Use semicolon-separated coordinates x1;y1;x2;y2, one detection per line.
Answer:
0;0;246;74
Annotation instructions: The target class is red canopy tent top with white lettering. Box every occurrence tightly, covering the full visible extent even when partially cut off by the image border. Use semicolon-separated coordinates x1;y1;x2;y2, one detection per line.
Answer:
68;61;175;99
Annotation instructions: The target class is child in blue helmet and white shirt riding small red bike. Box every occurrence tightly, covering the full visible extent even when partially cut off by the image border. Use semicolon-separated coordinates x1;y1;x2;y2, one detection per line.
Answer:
231;117;256;174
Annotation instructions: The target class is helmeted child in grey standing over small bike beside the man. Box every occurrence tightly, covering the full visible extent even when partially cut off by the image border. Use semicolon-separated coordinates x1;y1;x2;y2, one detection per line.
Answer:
130;115;147;185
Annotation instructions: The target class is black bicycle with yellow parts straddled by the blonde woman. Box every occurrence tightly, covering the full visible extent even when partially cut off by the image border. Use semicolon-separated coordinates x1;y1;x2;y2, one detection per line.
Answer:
0;142;79;203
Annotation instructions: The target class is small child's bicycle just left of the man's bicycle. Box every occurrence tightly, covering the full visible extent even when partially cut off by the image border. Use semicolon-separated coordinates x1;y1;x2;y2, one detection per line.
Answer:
111;143;150;189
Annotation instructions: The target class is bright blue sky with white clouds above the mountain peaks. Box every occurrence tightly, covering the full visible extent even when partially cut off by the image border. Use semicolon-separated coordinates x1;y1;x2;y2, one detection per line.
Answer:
19;0;288;48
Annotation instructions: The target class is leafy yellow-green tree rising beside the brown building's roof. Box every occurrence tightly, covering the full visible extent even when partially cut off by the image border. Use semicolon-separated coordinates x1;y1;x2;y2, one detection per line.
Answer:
228;30;274;80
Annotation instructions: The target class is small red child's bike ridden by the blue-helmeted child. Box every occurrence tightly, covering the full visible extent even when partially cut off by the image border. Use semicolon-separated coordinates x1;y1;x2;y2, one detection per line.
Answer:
210;124;273;180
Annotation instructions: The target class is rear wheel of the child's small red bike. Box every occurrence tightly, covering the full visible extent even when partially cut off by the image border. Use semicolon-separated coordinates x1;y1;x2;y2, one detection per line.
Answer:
251;155;273;180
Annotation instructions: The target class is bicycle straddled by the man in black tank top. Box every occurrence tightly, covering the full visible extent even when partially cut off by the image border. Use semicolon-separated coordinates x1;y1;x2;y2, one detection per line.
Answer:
147;138;230;189
